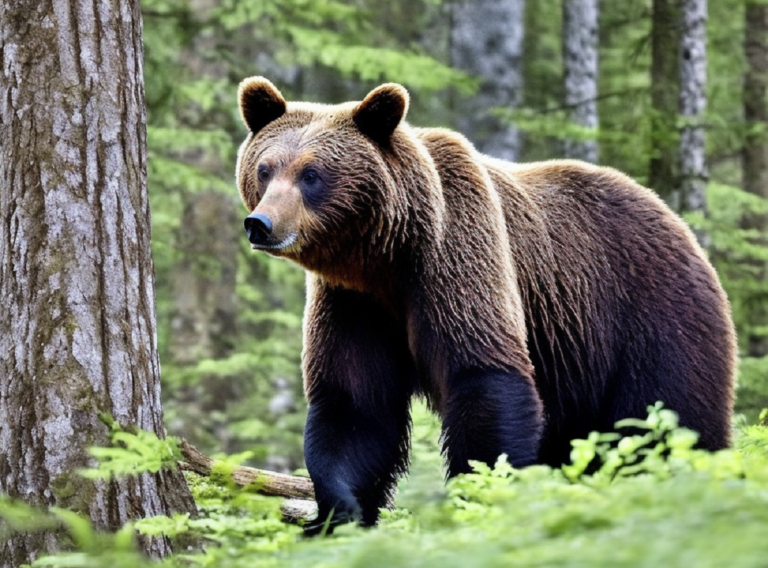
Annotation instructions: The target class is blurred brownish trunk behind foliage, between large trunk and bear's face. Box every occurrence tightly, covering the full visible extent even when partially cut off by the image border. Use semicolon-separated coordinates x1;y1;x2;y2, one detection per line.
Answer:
158;0;243;452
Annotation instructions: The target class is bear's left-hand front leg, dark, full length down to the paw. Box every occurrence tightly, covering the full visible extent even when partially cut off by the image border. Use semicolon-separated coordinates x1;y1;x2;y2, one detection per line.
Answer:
304;282;414;534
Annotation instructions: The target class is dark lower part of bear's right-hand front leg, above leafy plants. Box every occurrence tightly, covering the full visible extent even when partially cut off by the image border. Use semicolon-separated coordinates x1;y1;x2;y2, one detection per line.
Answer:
443;368;544;477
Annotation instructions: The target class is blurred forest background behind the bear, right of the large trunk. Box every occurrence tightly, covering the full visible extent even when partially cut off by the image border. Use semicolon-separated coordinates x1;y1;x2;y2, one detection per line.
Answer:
143;0;768;471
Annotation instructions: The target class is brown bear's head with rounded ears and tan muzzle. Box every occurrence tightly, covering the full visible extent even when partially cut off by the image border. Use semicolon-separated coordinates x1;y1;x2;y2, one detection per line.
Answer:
232;77;439;281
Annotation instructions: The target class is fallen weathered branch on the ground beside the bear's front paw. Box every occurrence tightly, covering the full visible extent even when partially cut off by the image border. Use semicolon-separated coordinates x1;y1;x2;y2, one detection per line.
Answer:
179;440;317;523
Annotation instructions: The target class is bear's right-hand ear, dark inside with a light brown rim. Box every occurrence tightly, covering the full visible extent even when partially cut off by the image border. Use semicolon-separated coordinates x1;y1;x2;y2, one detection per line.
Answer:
352;83;409;142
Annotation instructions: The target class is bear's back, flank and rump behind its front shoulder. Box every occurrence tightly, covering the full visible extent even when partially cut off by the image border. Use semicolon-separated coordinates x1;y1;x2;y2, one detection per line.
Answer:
418;129;736;463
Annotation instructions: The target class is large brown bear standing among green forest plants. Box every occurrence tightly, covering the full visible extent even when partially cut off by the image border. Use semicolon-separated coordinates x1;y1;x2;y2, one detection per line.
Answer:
237;77;736;532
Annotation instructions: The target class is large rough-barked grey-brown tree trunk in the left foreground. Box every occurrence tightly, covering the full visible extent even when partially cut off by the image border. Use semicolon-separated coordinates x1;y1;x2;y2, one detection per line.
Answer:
0;0;200;566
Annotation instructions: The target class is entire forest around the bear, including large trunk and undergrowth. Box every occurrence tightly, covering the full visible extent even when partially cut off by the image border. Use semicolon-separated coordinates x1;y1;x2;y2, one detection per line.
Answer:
0;0;768;568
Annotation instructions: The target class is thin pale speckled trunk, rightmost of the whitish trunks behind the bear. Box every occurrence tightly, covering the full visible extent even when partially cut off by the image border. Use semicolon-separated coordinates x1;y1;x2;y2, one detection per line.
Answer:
679;0;709;233
